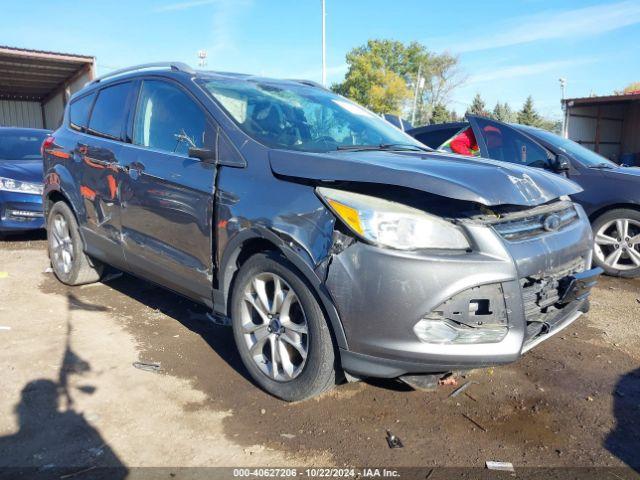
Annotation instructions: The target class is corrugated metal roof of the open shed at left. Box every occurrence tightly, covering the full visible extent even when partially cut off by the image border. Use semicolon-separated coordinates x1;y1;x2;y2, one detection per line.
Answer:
0;46;95;101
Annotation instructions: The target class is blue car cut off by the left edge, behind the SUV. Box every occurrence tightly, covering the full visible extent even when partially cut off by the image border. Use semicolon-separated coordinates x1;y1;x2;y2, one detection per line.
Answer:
0;128;50;235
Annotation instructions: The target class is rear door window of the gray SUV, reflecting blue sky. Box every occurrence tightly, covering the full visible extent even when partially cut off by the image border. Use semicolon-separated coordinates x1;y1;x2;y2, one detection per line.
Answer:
89;82;132;140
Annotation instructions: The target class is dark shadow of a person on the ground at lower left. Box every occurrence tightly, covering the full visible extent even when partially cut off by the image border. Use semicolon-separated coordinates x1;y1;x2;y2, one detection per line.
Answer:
0;294;127;479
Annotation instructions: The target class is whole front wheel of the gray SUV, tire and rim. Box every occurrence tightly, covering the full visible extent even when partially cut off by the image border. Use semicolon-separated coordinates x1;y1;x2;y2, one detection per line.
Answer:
231;253;336;401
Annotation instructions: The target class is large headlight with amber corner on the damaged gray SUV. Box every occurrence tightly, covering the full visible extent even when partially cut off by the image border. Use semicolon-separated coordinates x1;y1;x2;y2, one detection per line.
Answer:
316;187;469;250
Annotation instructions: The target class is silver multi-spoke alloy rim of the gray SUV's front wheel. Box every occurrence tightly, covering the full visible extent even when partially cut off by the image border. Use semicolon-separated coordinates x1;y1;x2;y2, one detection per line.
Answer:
241;272;309;382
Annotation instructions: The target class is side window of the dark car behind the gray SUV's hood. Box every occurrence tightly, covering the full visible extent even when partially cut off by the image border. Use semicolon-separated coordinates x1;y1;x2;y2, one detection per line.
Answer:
477;118;549;168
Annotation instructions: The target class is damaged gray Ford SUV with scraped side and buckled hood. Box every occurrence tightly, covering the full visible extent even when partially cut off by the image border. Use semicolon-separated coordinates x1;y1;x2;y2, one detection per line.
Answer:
43;63;600;401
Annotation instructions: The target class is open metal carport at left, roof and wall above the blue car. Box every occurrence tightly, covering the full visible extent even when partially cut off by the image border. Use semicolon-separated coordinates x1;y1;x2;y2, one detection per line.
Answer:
0;46;95;129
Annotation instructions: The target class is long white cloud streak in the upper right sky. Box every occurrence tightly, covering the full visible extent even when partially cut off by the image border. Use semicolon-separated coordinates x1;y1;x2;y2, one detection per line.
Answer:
433;0;640;53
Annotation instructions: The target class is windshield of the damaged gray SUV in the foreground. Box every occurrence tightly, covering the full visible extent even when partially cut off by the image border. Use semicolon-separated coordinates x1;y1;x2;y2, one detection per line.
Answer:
202;78;424;152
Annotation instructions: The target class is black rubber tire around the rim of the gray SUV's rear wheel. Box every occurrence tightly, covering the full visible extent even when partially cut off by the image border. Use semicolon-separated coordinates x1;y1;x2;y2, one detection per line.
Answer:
47;202;104;286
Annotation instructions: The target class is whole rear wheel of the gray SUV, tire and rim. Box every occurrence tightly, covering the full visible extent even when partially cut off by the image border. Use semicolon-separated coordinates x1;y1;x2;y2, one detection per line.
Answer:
47;202;103;286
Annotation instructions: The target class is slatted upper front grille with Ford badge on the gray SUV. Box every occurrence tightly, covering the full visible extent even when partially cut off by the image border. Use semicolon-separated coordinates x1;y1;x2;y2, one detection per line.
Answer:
493;202;579;241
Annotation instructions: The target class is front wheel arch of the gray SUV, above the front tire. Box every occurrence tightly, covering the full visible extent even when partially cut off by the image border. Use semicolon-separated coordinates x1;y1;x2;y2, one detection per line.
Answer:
214;229;347;348
